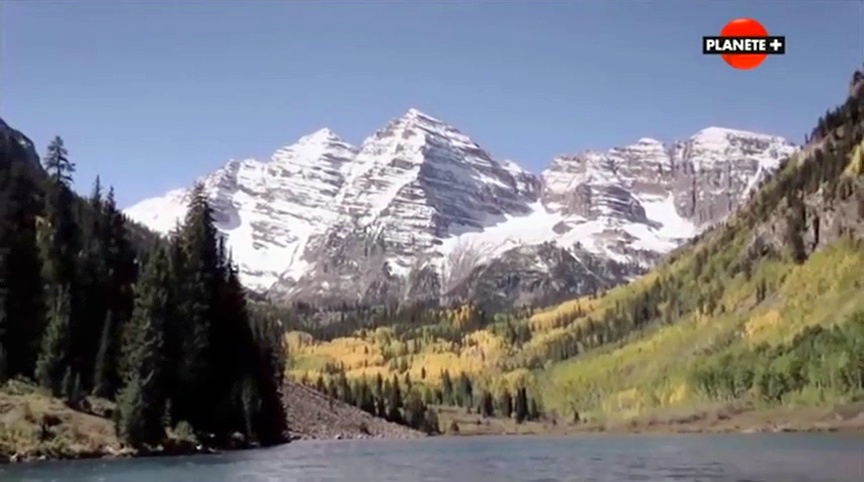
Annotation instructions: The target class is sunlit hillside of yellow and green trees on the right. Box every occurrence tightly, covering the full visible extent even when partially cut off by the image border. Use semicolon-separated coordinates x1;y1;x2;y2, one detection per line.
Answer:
286;72;864;428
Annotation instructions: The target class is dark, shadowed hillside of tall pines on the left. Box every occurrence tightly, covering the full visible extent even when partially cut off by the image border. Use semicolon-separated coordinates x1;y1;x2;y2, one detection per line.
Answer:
0;129;286;454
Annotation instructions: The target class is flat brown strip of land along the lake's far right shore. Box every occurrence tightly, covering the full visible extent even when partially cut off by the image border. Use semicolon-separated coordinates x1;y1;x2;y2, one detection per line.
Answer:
438;402;864;436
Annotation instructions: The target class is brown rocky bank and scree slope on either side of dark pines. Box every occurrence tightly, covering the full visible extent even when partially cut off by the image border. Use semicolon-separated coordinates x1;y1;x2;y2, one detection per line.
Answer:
0;381;426;464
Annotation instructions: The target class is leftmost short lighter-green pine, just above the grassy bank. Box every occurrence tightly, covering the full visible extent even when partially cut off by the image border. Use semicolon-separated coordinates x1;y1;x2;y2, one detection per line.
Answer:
35;288;70;396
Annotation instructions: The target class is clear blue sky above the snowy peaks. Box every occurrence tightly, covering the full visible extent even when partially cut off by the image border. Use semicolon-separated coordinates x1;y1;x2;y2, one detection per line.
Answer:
0;0;864;206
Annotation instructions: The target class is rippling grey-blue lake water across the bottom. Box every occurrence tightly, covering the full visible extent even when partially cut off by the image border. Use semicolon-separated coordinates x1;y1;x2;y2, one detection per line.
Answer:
0;433;864;482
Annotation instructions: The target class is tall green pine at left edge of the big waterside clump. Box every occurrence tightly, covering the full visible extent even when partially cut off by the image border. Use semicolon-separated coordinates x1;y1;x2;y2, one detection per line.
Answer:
116;248;169;448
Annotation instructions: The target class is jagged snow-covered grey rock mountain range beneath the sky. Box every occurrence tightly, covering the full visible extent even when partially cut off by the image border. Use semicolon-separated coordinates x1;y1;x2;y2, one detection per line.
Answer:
126;109;796;305
